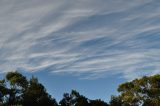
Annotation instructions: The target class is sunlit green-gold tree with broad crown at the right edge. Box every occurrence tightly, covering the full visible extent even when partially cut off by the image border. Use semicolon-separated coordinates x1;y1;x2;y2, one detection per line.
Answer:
118;75;160;106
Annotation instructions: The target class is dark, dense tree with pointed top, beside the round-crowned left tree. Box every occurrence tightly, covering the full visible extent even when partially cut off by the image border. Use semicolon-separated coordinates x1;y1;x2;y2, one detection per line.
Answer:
23;77;57;106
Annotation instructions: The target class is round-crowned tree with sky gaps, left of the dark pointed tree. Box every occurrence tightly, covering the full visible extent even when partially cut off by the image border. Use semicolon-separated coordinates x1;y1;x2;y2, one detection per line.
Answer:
6;72;28;105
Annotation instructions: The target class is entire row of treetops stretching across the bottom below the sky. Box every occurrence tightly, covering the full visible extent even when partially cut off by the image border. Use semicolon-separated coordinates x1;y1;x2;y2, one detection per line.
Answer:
0;72;160;106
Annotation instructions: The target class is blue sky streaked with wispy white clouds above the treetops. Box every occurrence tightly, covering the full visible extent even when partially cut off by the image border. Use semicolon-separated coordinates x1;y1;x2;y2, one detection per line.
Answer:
0;0;160;100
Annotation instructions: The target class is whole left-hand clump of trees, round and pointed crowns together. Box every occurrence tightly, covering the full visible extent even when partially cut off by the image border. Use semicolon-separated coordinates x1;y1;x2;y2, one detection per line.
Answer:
0;72;57;106
